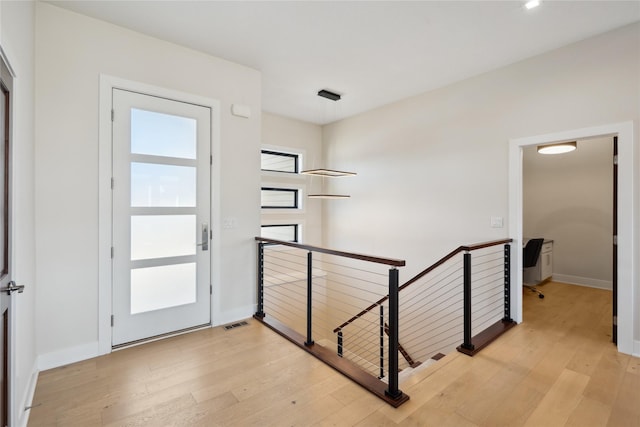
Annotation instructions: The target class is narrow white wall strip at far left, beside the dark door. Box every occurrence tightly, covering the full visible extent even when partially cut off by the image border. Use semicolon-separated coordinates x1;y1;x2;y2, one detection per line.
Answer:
0;1;37;425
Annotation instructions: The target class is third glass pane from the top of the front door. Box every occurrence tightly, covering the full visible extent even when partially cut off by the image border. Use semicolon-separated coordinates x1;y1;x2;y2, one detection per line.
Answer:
131;215;196;260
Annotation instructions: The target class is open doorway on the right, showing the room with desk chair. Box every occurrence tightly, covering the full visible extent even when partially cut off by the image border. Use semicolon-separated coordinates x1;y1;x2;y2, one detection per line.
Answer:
522;136;617;343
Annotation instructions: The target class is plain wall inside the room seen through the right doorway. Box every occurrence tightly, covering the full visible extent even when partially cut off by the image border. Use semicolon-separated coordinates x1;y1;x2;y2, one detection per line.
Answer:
523;138;613;289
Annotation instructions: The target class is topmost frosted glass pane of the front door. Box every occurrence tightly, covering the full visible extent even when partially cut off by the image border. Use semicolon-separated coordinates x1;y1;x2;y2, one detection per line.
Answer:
131;108;197;159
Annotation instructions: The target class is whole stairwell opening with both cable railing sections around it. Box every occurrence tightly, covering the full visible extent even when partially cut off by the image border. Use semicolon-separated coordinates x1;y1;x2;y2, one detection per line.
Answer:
254;237;515;407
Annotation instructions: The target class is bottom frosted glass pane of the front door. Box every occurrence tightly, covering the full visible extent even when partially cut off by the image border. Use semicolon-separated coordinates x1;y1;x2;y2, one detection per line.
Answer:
131;263;196;314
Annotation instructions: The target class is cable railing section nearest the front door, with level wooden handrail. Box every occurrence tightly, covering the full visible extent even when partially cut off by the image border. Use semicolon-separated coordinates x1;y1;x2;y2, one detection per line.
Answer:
254;237;409;407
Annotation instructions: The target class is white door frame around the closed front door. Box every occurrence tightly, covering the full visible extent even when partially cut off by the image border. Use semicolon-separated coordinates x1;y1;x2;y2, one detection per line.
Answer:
98;74;221;355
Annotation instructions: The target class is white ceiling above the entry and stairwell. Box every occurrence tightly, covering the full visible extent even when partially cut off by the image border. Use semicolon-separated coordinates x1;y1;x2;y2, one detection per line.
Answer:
49;0;640;124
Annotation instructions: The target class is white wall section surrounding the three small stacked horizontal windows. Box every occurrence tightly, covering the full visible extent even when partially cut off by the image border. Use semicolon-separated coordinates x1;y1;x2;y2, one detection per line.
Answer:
262;113;322;245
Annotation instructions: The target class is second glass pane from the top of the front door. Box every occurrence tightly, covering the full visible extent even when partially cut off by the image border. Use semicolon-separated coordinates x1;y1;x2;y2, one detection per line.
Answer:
131;162;196;207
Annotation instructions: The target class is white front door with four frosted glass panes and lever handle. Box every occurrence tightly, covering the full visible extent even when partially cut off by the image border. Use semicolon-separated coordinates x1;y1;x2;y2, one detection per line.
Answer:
112;89;211;346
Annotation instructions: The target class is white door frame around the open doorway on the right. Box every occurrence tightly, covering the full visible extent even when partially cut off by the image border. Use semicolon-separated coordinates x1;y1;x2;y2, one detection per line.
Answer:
509;121;639;354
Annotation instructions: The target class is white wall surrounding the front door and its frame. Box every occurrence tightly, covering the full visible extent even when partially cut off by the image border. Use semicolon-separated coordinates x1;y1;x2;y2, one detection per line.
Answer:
35;3;261;367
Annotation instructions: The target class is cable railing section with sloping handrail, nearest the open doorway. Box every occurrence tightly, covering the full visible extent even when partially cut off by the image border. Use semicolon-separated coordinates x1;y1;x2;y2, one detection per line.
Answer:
334;239;515;367
